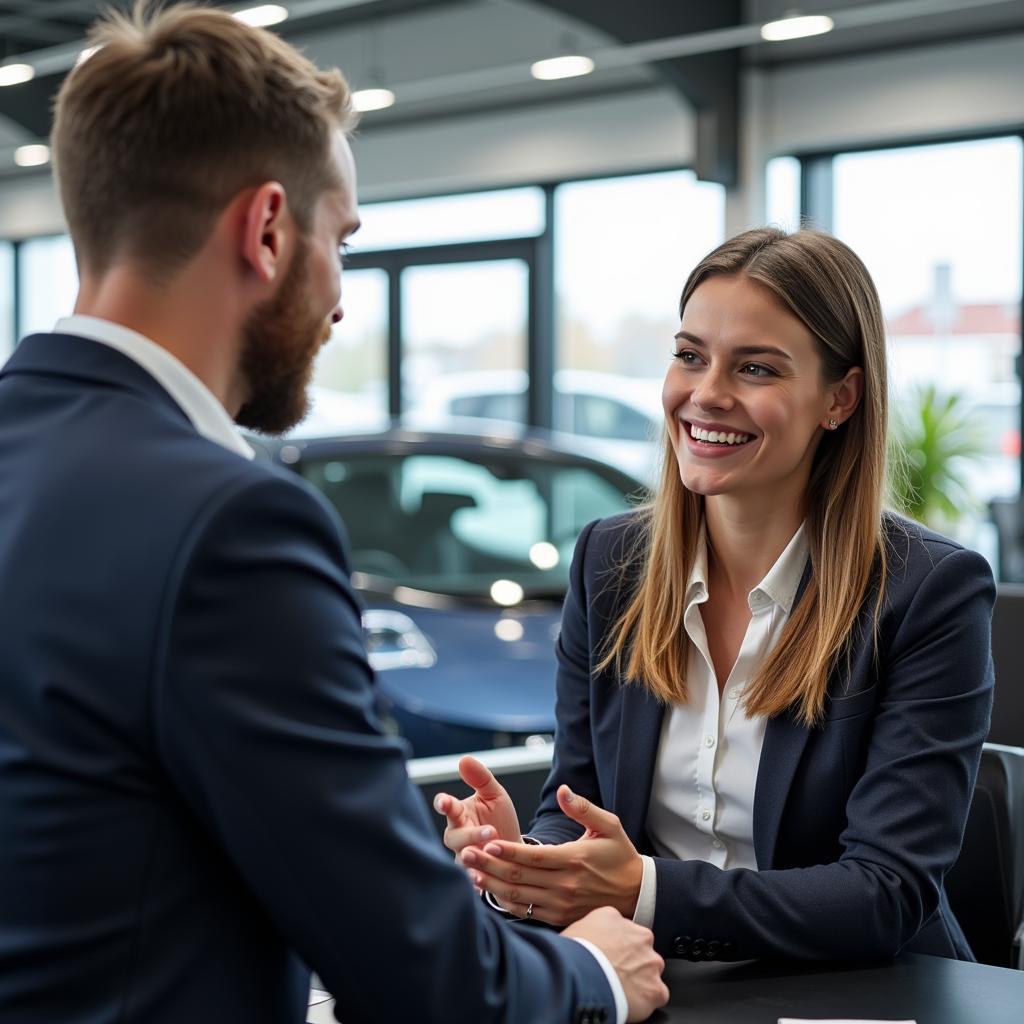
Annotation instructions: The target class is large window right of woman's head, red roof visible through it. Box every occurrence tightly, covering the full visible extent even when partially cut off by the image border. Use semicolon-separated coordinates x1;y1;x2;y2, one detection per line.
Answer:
834;138;1022;561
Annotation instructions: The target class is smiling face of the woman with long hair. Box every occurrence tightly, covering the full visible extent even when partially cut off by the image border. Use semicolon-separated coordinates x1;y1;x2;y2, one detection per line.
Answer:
662;275;847;508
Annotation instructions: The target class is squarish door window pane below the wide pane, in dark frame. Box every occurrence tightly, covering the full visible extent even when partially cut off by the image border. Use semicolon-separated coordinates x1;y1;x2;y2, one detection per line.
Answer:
401;259;529;426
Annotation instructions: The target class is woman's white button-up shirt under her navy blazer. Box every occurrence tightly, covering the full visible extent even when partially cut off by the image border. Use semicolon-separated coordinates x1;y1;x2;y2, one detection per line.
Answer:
633;525;808;927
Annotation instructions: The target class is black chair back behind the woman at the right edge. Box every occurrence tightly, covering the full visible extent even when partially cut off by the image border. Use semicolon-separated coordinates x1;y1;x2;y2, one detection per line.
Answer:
945;743;1024;971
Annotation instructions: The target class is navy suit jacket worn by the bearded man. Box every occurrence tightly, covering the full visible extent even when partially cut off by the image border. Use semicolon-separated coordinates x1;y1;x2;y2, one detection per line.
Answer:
0;335;614;1024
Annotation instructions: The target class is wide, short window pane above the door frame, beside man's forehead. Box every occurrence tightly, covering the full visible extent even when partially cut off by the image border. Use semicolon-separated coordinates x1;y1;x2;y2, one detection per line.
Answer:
352;188;544;252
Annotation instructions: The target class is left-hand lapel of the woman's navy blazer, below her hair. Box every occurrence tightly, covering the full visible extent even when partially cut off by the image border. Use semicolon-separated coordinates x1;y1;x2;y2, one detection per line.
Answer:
612;683;665;849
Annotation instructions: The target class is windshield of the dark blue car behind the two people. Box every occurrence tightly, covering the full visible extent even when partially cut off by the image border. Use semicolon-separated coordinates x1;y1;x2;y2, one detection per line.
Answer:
295;452;635;604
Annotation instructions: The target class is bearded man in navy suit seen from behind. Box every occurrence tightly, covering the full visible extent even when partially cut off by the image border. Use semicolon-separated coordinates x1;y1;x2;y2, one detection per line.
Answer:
0;6;668;1024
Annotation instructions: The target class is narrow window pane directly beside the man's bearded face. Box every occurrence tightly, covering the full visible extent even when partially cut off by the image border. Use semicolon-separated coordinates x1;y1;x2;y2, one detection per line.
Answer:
301;270;388;434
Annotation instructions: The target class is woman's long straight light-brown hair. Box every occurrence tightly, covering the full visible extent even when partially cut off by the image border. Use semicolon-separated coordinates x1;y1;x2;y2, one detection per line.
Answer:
597;227;888;726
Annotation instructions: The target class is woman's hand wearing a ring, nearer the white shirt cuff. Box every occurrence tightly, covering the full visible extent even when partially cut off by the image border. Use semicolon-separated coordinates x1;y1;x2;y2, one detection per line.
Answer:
462;785;643;928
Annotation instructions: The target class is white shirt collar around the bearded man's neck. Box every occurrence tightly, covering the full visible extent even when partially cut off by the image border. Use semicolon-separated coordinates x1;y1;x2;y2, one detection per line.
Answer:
53;315;254;459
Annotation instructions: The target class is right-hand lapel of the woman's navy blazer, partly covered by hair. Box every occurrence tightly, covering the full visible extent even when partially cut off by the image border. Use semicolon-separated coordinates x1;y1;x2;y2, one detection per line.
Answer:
754;559;811;870
